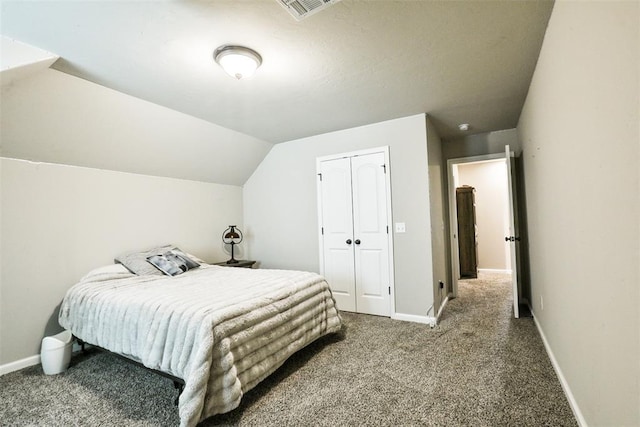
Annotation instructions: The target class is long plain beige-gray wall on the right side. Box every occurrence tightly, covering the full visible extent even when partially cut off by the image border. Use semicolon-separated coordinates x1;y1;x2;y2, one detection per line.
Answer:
518;1;640;426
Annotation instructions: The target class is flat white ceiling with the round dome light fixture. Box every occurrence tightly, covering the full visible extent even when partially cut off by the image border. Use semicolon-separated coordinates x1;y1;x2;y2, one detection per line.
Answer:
0;0;553;143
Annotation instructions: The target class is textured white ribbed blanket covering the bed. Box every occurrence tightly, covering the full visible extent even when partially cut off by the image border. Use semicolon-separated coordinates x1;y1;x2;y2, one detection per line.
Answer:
59;265;341;426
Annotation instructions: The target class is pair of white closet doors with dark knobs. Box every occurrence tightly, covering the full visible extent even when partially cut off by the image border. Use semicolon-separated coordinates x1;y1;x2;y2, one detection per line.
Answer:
318;151;392;316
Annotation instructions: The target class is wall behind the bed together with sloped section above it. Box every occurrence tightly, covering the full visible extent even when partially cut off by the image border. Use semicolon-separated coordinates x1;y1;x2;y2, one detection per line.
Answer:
0;69;250;372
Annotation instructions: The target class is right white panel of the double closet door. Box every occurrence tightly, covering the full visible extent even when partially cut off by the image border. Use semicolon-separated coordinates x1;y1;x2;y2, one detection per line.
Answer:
351;153;390;316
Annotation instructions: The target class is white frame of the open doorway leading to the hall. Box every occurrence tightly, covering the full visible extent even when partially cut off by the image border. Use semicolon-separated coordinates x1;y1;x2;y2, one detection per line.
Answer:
447;153;506;298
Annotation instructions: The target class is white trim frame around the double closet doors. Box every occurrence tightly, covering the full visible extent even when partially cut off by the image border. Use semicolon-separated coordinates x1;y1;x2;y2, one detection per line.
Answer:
316;145;396;318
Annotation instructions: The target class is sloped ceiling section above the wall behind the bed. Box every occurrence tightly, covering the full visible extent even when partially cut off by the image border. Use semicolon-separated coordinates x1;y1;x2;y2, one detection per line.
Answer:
0;38;272;185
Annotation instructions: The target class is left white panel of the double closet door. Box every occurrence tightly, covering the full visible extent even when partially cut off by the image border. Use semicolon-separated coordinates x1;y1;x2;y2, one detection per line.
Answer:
320;158;356;311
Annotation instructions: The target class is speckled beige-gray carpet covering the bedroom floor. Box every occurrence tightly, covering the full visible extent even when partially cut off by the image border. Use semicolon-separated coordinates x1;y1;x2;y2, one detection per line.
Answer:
0;275;576;426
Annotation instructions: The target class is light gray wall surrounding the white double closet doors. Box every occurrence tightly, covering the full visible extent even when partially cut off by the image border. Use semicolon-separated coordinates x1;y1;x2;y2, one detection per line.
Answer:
244;114;433;316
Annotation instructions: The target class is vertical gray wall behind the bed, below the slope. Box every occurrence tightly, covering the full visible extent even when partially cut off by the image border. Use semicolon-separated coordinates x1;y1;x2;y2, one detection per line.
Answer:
0;158;242;365
